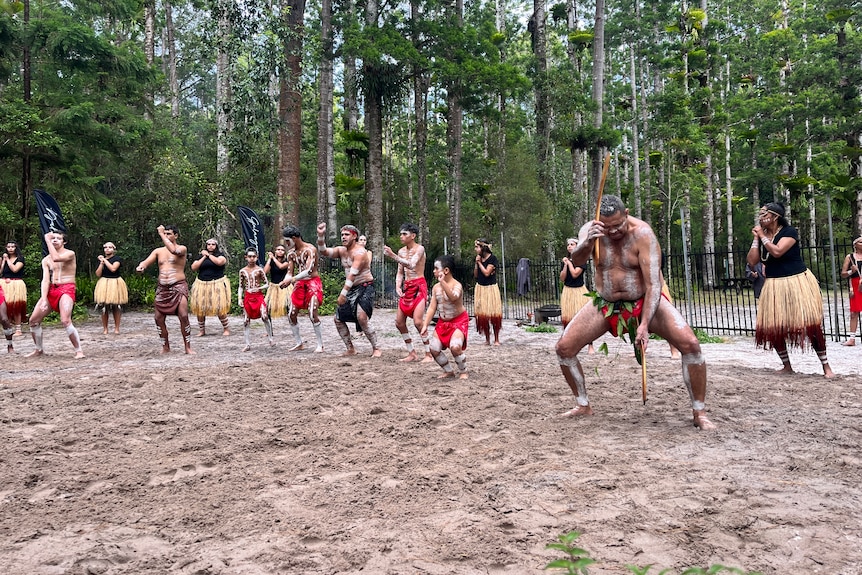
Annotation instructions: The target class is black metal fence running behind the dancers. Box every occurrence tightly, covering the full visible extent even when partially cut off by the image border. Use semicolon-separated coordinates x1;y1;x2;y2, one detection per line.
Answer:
324;244;852;340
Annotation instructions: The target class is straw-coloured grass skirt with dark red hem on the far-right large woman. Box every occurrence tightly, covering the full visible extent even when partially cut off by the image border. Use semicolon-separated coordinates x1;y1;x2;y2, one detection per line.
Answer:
754;270;823;349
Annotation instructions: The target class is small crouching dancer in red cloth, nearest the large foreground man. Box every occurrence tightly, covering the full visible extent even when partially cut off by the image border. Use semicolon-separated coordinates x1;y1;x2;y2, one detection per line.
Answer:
421;255;470;379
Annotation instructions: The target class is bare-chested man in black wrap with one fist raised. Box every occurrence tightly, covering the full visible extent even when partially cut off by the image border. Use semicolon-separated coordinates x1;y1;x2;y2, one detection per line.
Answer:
317;222;383;357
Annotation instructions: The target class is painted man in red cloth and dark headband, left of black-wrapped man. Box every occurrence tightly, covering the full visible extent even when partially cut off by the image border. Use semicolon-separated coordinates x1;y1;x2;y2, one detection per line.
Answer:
280;226;323;353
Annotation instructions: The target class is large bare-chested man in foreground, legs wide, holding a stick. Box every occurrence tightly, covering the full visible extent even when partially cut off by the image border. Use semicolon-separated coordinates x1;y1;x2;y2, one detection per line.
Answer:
556;195;715;429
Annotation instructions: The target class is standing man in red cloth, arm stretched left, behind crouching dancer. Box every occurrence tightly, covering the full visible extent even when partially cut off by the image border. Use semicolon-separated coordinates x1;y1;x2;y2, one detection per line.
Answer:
383;223;433;362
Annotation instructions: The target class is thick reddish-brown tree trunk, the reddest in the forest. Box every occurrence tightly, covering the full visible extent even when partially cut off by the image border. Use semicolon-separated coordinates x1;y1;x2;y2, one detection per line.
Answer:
274;0;305;236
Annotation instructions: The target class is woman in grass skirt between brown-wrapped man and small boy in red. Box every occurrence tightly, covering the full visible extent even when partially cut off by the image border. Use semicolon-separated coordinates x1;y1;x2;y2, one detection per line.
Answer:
189;238;231;336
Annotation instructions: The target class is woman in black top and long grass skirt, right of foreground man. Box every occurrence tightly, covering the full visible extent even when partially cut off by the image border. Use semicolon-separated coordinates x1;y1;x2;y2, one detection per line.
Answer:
747;202;835;377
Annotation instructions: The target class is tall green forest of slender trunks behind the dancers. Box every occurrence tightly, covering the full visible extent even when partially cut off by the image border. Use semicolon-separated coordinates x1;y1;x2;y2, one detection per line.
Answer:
0;0;862;285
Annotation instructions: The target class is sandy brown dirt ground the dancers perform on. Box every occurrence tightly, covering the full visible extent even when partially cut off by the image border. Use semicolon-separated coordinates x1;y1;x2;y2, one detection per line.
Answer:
0;310;862;575
